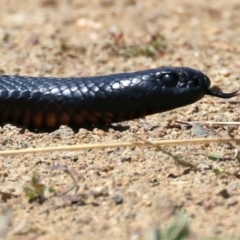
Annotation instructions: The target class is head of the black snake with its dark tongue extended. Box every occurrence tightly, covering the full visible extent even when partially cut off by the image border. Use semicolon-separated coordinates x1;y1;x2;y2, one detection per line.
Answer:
148;67;240;111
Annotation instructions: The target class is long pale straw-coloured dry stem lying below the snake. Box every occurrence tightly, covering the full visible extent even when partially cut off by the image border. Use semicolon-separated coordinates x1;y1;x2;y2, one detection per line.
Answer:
0;137;240;156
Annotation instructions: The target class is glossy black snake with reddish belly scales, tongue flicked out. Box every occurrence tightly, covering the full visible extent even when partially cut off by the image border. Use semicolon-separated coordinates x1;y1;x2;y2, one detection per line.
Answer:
0;67;237;129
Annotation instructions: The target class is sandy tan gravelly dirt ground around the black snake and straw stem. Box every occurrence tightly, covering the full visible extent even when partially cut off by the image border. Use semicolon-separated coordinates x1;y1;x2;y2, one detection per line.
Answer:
0;0;240;240
